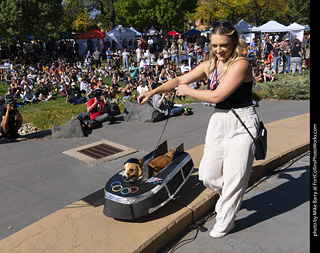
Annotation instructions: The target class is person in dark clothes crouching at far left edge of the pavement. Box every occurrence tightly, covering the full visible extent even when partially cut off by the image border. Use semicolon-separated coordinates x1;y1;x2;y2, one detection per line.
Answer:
0;99;23;139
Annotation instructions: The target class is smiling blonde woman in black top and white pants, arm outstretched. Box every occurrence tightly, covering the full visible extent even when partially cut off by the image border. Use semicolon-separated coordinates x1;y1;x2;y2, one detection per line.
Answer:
138;21;259;238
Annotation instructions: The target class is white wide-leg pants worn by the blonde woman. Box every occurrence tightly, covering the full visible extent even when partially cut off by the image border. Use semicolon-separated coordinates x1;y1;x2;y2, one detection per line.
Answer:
199;106;259;232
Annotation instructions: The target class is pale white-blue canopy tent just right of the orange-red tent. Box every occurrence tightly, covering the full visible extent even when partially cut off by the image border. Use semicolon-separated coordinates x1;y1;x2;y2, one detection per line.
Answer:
106;25;136;50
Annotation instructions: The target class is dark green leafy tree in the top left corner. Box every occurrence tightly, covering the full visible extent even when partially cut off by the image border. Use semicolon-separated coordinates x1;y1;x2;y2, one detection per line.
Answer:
0;0;62;42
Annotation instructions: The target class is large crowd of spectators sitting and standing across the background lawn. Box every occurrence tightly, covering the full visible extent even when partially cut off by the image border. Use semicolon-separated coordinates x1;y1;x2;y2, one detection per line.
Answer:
0;29;310;140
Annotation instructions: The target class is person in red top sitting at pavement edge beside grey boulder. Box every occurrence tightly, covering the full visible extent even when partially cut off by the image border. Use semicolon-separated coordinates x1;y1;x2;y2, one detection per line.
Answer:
87;90;111;123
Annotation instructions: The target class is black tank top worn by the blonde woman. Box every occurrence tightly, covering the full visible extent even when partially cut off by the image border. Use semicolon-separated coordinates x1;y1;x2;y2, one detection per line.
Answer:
209;81;253;109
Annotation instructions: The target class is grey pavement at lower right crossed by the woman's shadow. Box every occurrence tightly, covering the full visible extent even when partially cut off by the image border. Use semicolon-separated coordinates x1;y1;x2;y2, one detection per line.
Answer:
165;155;310;253
